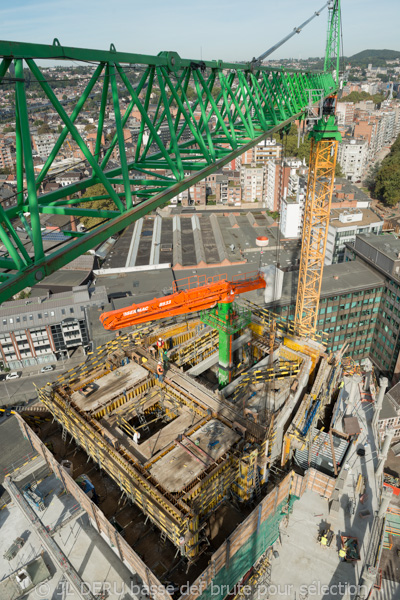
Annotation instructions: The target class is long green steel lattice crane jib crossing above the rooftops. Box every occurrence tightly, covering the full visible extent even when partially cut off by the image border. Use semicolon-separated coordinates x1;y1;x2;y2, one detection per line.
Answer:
0;40;337;302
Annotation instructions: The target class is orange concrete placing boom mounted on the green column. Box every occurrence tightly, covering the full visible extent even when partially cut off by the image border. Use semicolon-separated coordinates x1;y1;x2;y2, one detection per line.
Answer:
100;272;265;330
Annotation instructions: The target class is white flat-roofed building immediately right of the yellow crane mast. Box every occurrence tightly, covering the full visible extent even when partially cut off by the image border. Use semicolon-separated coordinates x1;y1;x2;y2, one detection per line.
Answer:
325;208;383;265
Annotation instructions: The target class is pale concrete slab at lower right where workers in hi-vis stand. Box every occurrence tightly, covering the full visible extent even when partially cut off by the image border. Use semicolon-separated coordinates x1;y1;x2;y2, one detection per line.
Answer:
264;382;380;600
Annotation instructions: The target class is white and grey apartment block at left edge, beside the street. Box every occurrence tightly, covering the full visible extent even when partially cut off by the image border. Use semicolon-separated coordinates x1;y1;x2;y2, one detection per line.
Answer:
0;286;108;370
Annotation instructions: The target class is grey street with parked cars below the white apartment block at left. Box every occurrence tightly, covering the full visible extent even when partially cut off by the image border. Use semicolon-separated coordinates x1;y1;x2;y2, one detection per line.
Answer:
0;354;85;406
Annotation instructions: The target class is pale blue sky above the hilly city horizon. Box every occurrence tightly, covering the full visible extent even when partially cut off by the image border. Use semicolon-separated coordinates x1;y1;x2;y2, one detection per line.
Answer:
0;0;400;60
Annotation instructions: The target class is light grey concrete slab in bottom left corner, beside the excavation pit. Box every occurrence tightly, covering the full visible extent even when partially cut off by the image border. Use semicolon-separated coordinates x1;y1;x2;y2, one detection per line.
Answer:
0;473;138;600
